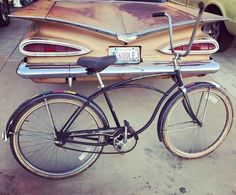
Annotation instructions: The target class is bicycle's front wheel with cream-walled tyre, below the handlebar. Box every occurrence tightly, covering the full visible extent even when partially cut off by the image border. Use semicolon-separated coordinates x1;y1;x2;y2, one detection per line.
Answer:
161;83;233;159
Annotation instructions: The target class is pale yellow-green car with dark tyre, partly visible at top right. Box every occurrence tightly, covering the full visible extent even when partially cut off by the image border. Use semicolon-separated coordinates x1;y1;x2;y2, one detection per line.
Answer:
169;0;236;52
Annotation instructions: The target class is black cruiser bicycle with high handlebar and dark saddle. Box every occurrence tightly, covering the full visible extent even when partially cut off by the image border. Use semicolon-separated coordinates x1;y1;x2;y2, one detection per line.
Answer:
4;3;233;179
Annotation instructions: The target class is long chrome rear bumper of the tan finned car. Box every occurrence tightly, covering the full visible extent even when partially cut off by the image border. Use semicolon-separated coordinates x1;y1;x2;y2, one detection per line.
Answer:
17;60;220;79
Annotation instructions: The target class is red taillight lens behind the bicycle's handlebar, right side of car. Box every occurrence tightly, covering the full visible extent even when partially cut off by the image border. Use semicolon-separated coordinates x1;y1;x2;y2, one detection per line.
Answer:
174;43;216;51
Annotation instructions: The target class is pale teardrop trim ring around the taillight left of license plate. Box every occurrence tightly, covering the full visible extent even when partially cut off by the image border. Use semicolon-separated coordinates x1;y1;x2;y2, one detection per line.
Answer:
19;38;91;56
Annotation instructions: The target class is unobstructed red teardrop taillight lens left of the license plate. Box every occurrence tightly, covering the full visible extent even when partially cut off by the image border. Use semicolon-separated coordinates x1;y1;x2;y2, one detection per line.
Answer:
23;43;81;53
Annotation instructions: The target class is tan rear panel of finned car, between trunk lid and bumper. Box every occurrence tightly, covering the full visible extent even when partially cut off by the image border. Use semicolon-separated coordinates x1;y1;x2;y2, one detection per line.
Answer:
22;22;209;63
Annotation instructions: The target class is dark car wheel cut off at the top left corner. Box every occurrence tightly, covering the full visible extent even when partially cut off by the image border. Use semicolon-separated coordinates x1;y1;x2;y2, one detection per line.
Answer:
0;0;10;27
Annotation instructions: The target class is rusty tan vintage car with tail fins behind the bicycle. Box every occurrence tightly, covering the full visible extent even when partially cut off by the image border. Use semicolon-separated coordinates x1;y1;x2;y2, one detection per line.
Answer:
10;0;224;83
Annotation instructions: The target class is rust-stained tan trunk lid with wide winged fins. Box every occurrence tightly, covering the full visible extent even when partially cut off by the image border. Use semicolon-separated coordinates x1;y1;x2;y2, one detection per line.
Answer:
10;1;225;36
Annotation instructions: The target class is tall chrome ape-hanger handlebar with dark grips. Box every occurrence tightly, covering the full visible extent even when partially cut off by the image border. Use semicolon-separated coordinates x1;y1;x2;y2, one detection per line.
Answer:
152;2;205;57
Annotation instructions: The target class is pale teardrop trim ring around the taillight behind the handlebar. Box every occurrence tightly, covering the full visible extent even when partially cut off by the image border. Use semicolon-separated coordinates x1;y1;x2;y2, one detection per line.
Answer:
159;38;219;55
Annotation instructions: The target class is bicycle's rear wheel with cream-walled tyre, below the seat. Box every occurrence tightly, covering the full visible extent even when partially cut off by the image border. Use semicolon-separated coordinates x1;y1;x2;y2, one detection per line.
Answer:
10;94;105;179
